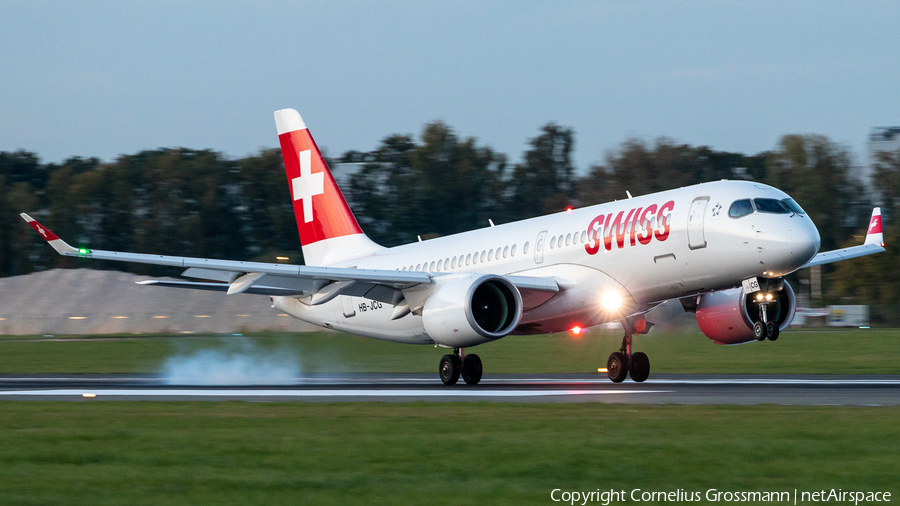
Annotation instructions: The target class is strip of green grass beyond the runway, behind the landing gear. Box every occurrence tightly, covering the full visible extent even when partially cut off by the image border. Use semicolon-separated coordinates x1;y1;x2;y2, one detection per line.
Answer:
0;329;900;374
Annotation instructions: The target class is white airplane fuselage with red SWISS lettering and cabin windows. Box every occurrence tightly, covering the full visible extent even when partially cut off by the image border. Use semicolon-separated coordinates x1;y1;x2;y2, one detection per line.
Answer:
275;181;819;344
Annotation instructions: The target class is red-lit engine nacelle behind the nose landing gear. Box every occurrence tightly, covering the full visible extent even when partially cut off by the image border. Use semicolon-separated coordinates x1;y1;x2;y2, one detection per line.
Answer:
697;282;797;344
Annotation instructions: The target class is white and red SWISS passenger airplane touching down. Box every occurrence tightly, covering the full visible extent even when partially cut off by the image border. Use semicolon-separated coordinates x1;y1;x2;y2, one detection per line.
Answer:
21;109;884;385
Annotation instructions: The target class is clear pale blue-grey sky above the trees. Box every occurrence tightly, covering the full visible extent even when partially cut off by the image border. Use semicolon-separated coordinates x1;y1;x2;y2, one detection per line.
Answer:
0;0;900;171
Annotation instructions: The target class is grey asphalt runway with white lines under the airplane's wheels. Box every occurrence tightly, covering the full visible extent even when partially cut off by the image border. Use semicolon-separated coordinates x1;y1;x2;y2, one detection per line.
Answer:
0;374;900;406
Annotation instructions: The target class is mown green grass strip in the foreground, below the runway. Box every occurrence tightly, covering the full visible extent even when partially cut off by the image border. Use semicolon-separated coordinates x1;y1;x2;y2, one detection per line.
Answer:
0;402;900;506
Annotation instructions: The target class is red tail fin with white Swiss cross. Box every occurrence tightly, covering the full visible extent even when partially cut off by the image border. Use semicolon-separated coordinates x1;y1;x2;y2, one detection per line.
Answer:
275;109;380;265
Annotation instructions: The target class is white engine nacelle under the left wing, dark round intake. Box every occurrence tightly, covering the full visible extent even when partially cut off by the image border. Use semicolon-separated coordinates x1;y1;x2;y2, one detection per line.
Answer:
422;274;522;348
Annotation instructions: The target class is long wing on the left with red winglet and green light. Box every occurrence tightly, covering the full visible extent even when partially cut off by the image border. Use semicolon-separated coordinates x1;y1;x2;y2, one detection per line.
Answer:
21;213;560;305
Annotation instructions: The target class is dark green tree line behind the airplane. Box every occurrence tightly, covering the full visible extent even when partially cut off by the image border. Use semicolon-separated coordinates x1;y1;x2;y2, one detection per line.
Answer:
0;122;900;302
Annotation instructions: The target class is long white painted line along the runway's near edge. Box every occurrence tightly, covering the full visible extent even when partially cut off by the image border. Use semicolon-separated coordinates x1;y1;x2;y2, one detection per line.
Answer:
0;388;667;397
